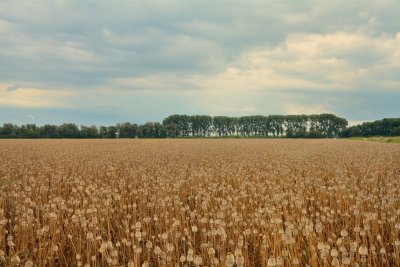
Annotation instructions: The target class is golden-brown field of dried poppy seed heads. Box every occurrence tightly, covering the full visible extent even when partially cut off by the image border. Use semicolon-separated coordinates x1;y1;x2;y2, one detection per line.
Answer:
0;139;400;266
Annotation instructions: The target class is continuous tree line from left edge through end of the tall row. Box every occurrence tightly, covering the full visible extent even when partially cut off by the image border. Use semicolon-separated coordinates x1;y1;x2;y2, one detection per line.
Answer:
0;114;347;138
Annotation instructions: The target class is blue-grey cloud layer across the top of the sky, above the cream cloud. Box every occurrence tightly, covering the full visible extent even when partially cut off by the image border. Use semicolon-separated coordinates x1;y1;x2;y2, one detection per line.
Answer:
0;1;396;86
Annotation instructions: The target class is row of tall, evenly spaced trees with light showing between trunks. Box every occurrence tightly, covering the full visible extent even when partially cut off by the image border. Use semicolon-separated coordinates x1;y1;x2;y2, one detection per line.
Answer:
163;114;348;137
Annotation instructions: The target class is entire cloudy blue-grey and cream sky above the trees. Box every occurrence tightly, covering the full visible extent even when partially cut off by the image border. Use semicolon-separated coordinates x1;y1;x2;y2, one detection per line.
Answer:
0;0;400;125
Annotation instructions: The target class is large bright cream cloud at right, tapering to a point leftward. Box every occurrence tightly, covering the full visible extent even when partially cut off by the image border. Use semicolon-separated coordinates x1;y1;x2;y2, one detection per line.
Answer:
111;32;400;93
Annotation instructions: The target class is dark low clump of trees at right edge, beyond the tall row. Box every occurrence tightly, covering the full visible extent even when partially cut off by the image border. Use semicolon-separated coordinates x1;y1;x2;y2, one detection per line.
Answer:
340;118;400;137
